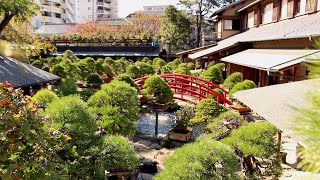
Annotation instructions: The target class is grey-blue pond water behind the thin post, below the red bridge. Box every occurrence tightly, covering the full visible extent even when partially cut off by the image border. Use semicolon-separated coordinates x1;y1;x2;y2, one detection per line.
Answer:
136;112;177;135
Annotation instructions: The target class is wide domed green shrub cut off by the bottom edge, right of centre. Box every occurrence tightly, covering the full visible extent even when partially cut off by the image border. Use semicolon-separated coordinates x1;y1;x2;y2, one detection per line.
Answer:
155;139;239;180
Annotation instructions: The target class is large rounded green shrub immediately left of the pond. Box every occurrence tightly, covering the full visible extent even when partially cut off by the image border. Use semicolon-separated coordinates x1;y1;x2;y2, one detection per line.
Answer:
88;80;139;135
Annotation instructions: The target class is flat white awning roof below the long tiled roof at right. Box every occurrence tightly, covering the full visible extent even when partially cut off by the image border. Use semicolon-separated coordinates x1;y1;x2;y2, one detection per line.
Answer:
221;49;320;71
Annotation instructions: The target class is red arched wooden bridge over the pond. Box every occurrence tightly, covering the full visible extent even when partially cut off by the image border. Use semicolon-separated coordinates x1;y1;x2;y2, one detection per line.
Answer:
134;74;232;105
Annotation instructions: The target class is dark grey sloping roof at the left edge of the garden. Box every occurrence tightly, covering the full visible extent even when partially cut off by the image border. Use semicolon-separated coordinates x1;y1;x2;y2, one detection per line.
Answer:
0;56;60;88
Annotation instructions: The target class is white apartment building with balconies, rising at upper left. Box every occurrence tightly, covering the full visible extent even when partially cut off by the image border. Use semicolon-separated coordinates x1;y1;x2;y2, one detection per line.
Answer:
38;0;118;24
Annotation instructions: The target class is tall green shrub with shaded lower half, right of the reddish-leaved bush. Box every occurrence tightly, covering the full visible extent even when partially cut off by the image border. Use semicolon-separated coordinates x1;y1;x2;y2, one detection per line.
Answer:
45;95;99;177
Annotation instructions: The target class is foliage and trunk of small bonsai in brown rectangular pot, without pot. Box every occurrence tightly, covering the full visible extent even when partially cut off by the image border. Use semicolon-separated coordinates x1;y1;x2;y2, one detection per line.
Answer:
175;106;195;130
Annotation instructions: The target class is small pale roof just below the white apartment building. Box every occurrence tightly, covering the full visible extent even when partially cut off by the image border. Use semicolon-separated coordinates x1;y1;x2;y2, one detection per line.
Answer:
36;24;75;35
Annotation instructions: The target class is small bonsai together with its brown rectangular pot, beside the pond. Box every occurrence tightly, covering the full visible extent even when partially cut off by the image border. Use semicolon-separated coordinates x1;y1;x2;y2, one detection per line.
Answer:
168;106;195;142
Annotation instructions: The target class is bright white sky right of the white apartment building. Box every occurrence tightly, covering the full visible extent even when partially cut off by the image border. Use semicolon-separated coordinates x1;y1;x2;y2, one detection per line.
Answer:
118;0;179;18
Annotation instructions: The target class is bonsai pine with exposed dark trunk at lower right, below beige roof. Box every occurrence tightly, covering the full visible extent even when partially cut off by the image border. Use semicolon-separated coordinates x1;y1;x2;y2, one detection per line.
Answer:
221;121;281;179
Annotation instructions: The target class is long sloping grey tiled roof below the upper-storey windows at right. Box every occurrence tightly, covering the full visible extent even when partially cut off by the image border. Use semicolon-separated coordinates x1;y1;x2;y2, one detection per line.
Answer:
189;14;320;59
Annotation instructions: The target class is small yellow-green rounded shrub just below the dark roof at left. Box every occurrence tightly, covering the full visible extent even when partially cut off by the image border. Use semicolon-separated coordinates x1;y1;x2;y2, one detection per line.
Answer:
31;89;58;106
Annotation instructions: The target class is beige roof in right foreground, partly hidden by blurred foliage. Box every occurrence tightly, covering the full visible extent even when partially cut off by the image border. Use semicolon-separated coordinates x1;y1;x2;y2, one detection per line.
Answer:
234;78;320;147
